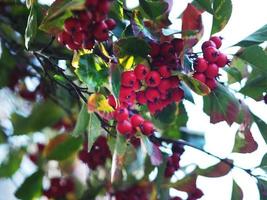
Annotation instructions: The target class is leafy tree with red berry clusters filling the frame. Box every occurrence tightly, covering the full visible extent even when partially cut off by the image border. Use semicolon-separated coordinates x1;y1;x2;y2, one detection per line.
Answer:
0;0;267;200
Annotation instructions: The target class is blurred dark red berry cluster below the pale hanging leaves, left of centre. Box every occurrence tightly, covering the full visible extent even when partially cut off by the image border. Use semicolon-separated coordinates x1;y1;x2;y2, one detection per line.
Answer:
79;136;111;170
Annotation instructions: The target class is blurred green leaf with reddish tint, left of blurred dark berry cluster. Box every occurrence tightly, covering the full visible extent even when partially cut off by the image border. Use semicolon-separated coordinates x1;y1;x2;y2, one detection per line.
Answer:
47;136;83;161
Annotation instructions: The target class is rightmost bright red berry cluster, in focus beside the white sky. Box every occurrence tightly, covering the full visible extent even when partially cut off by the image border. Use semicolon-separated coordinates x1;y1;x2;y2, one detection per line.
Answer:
193;36;229;90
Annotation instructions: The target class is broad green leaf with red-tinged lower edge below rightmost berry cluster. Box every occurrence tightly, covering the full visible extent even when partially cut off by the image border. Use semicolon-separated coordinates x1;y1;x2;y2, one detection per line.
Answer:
204;84;240;125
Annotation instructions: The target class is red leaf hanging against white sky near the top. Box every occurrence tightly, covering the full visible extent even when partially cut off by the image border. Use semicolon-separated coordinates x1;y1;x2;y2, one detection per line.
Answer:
182;4;203;48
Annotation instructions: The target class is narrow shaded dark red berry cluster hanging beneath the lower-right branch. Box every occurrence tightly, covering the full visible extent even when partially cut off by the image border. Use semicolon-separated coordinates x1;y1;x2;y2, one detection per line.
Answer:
165;143;184;178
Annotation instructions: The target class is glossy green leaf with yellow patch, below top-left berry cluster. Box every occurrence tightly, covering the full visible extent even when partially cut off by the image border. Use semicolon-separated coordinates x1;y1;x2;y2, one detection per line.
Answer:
75;54;108;89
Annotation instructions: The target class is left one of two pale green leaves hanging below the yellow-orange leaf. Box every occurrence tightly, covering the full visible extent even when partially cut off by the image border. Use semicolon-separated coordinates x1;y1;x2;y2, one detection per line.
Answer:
72;104;90;137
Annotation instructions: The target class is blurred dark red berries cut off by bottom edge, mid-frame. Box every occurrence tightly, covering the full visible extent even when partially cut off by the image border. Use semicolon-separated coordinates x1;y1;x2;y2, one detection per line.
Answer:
115;185;150;200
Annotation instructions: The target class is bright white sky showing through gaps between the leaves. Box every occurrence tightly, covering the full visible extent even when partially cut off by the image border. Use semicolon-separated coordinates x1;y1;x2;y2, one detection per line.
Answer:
0;0;267;200
